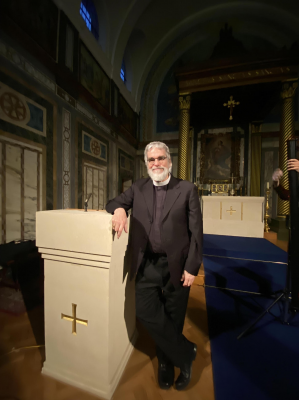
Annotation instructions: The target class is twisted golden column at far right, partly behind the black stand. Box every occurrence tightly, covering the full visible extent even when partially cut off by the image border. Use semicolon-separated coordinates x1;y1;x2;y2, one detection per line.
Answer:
277;80;298;216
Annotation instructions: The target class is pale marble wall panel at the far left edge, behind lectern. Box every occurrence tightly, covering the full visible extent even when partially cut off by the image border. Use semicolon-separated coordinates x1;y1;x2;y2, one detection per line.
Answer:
0;137;43;243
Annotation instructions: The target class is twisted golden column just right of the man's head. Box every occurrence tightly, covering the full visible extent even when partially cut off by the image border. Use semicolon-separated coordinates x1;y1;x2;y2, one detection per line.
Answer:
178;94;191;180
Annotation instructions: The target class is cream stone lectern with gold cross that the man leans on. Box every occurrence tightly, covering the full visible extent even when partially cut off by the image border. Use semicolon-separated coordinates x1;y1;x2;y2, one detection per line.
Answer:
36;210;136;399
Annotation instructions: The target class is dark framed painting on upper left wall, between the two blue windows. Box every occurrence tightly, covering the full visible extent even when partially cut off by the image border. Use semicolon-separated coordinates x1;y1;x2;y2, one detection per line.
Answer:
80;42;110;112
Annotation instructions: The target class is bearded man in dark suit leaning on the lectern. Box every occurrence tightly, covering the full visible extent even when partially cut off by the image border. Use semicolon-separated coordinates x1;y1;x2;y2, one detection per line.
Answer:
106;142;203;390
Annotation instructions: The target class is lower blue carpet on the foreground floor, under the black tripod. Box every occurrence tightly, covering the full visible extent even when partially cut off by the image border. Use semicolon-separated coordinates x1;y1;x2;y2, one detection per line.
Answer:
206;288;299;400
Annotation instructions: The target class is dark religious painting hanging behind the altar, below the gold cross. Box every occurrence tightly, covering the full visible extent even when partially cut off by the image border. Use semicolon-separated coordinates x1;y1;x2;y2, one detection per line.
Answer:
200;132;240;183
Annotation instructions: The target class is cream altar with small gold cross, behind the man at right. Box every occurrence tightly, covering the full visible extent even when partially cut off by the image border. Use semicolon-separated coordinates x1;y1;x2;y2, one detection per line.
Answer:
201;196;265;238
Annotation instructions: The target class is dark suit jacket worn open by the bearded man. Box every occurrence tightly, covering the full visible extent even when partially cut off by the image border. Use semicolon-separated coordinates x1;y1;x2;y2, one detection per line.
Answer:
106;176;203;286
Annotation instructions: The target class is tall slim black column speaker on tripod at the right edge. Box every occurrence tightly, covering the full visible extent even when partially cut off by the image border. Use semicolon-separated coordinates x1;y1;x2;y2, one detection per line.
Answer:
287;139;299;309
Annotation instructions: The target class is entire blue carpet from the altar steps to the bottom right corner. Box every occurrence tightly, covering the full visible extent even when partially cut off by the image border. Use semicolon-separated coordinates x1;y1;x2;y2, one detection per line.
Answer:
204;235;299;400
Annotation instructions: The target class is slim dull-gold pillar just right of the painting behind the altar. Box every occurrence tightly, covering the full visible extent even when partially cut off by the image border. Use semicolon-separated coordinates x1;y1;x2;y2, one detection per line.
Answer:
250;122;262;196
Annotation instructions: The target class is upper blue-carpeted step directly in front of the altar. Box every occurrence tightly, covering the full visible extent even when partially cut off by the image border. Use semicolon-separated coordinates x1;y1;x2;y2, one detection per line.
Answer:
203;234;287;263
